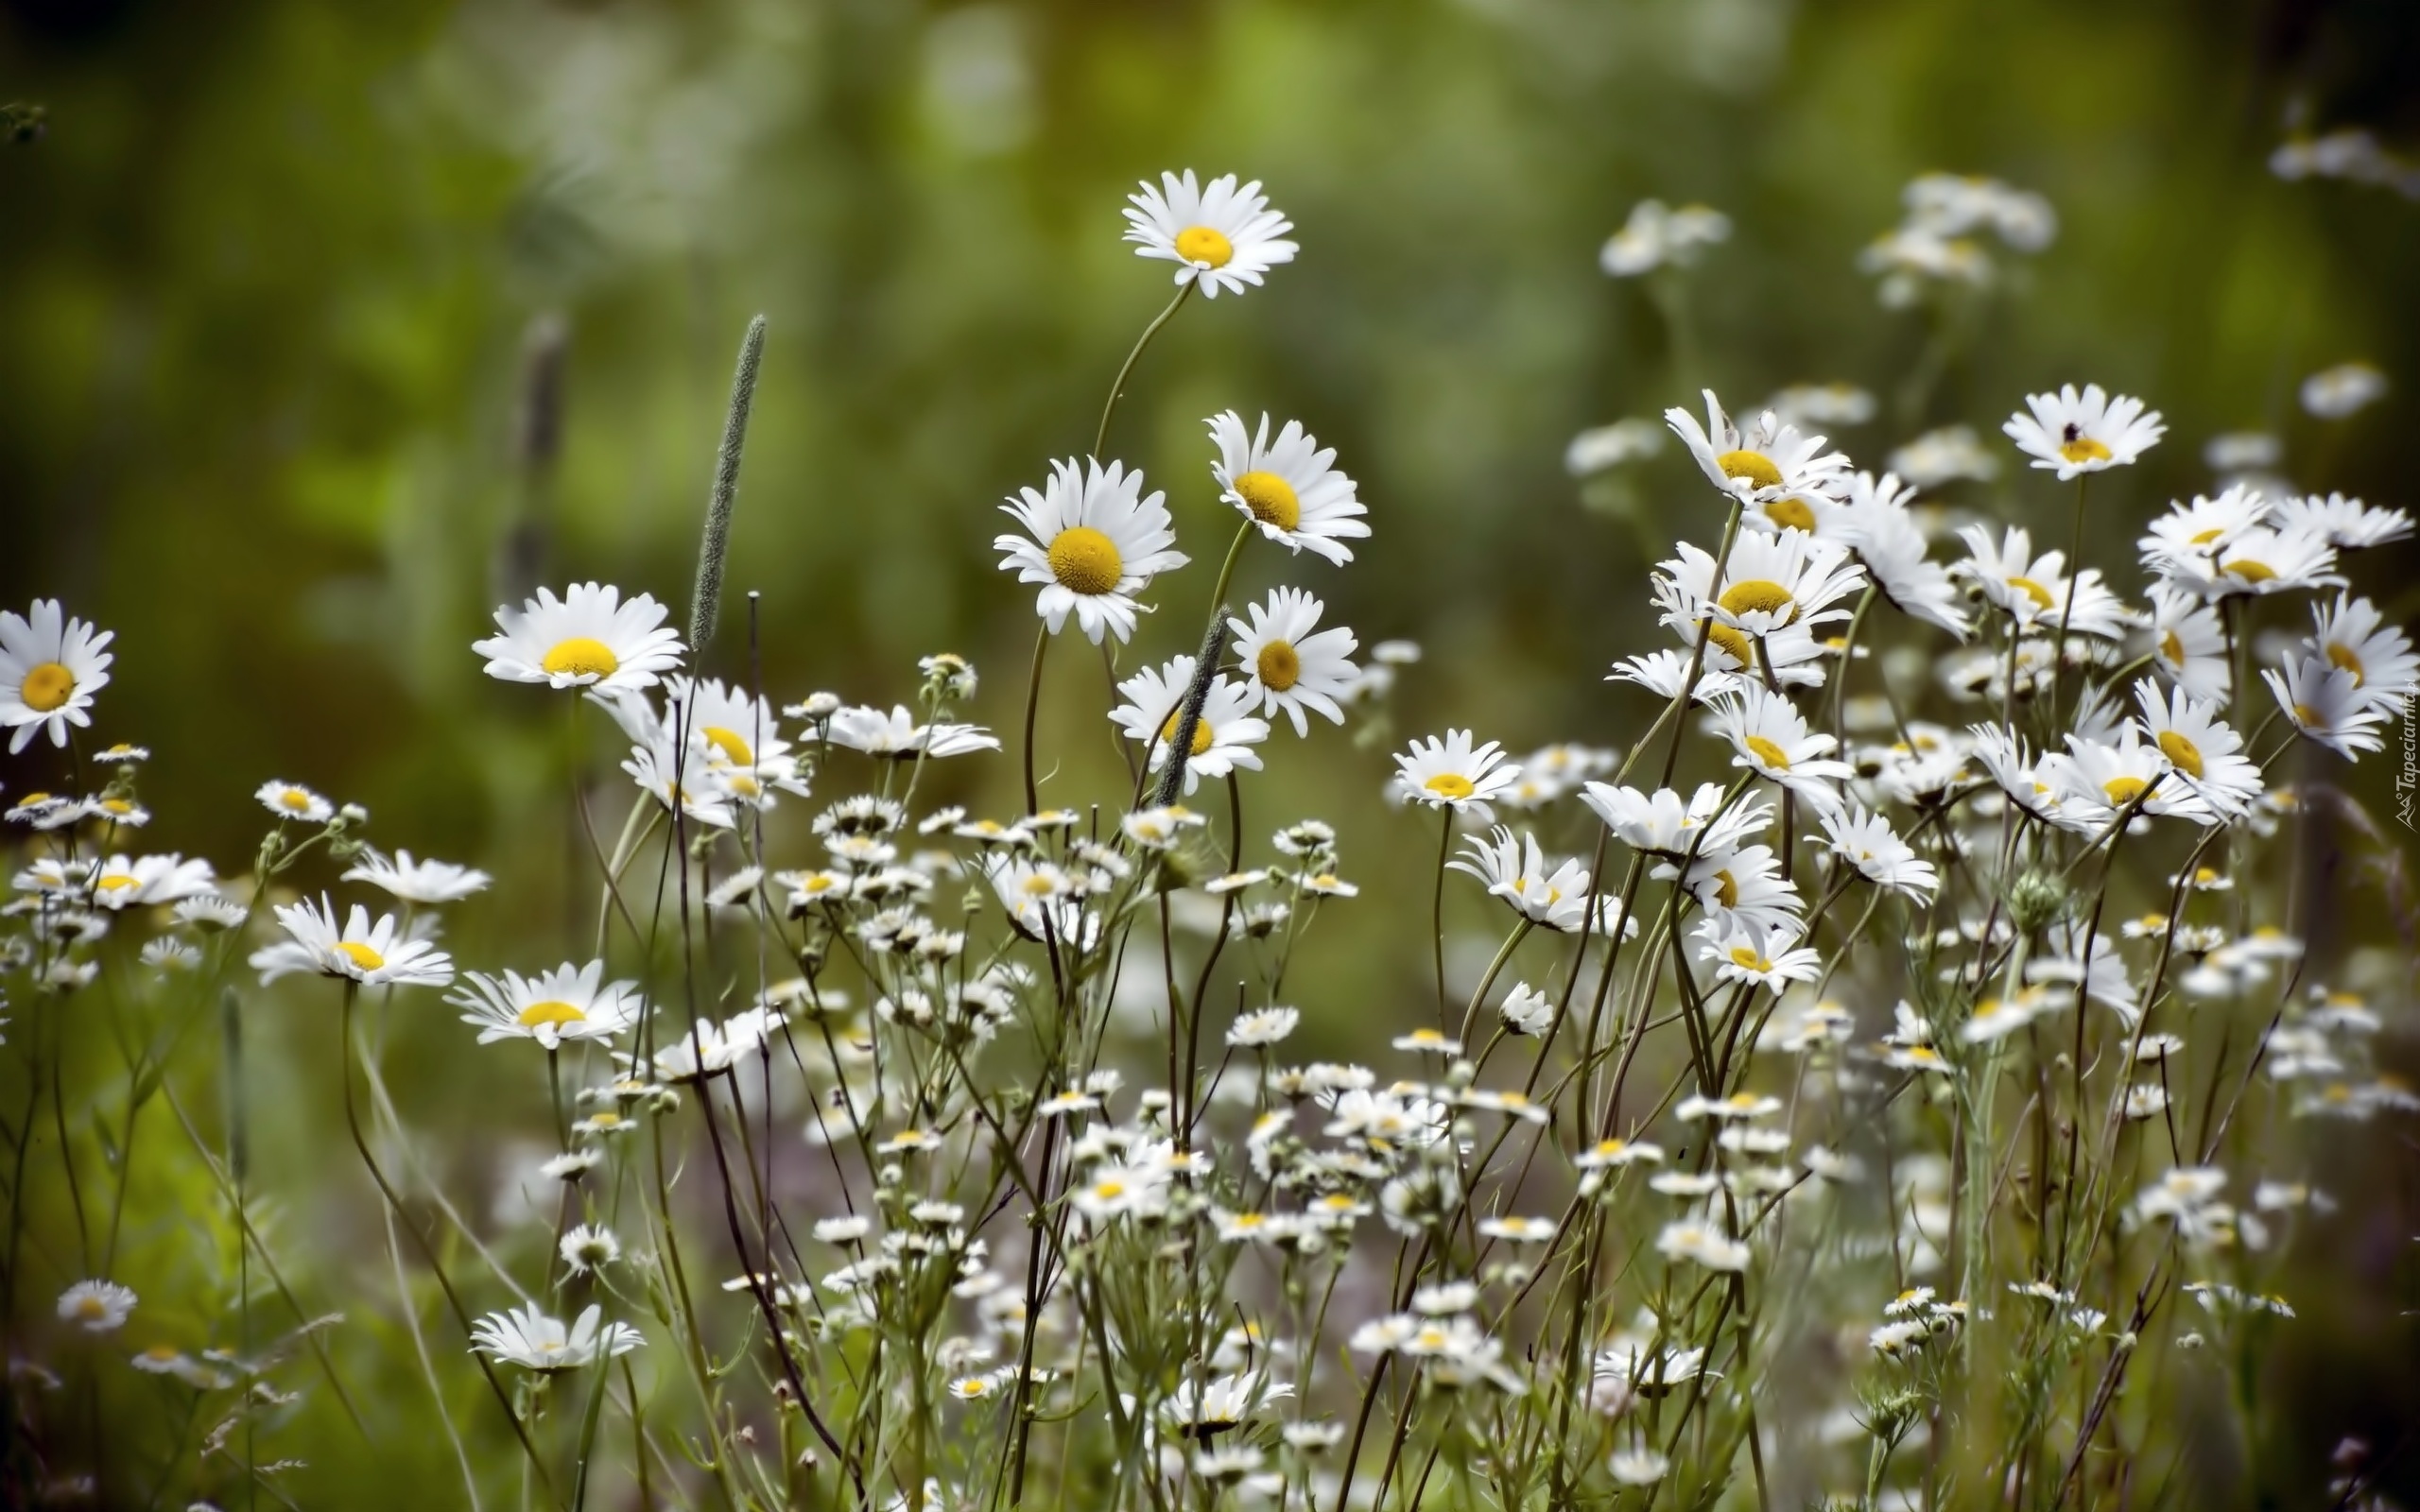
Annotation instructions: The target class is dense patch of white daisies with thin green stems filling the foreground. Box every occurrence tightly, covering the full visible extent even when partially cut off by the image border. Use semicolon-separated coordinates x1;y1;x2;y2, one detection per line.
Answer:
0;91;2420;1512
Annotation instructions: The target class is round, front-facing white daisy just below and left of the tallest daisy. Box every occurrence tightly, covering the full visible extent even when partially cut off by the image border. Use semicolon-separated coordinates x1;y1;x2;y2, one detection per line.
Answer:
993;447;1185;644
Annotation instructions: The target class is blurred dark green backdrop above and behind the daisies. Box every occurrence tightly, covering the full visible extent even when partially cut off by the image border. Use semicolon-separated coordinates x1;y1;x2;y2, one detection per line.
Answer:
0;0;2420;1489
